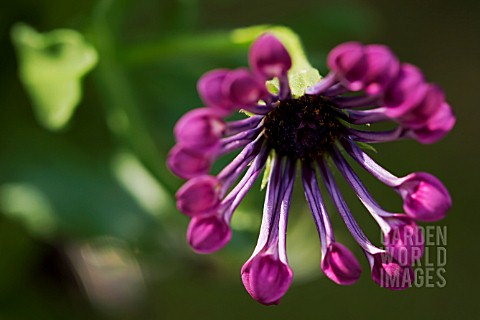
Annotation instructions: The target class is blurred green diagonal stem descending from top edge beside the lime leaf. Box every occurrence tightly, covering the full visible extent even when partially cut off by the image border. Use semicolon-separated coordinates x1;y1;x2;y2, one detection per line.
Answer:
88;0;176;194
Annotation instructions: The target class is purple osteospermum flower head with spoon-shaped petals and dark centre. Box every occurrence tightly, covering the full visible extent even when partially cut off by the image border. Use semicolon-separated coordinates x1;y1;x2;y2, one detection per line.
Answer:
168;33;455;304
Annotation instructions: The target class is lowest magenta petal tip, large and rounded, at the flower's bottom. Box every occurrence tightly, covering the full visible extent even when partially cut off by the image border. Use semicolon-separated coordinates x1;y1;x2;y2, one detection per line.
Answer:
241;253;293;305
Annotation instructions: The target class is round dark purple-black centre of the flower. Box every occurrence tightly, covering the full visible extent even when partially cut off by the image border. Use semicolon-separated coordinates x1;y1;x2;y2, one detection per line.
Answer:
265;95;343;160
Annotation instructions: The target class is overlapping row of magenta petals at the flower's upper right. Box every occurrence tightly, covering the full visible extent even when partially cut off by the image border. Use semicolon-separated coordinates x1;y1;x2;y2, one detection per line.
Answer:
318;42;455;144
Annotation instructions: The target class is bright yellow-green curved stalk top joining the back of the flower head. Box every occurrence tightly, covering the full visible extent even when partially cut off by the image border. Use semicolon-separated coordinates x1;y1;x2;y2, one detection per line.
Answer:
232;25;321;97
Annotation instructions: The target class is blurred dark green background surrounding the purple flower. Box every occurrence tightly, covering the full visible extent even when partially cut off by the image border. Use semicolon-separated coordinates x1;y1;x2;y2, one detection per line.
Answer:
0;0;480;320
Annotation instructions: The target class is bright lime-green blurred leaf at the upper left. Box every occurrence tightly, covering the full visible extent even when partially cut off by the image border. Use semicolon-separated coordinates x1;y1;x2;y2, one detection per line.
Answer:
11;24;97;130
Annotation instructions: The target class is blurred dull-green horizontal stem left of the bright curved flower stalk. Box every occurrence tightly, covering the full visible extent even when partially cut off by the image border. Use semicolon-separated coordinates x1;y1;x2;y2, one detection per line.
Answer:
121;32;249;66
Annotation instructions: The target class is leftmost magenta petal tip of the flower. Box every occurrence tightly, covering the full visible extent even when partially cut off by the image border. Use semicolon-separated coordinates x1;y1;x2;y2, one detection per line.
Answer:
167;144;213;179
